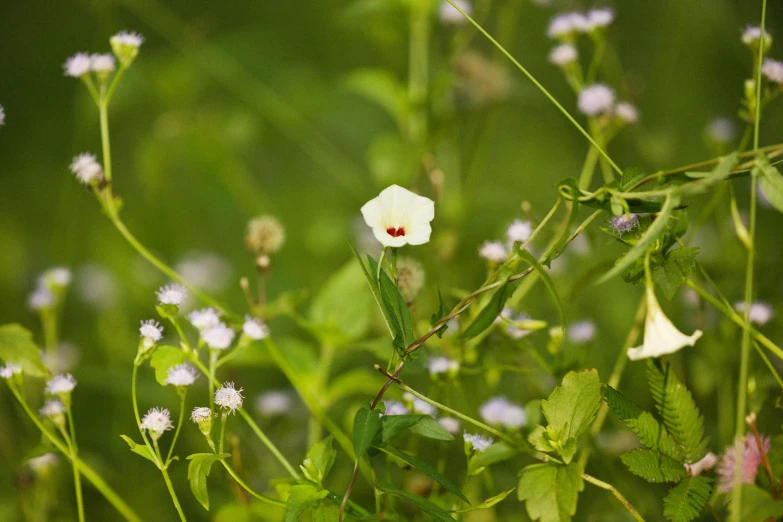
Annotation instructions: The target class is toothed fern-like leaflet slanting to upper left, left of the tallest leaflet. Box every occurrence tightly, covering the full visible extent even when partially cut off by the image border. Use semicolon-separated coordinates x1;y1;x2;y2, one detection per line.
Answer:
603;385;683;462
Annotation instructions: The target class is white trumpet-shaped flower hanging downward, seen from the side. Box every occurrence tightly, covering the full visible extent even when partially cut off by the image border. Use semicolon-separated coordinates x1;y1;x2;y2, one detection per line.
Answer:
628;288;702;361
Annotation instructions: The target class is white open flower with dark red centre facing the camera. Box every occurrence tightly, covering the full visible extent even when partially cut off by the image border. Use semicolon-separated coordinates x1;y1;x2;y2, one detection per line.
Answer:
362;185;435;248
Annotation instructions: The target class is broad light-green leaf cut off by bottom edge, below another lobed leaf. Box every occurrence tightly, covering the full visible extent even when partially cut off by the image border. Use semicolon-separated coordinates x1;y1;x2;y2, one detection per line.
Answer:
517;463;584;522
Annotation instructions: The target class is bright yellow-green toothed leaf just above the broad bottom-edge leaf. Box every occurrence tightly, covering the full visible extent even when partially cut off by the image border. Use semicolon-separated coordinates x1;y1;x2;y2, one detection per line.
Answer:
541;370;602;442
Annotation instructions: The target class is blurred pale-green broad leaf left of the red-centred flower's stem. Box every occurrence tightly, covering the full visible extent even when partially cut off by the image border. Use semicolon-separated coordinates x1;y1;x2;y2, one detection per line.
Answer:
310;263;372;343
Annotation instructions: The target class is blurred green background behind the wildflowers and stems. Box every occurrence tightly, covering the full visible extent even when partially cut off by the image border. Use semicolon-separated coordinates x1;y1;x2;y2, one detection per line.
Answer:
0;0;783;521
